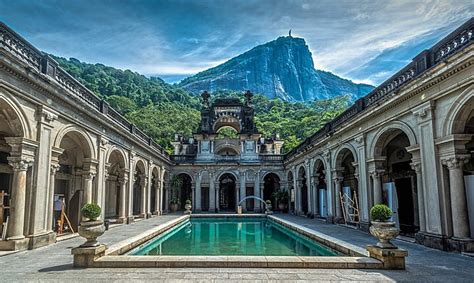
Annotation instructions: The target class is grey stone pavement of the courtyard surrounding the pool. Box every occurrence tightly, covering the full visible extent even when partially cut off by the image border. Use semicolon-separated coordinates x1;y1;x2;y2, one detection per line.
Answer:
0;215;474;282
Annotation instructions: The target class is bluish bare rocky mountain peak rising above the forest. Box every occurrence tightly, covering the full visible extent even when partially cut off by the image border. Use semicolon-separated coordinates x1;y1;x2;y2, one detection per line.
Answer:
179;36;374;101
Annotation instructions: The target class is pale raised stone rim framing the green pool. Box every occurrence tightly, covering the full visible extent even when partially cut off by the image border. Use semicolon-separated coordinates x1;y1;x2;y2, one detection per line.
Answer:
91;214;383;269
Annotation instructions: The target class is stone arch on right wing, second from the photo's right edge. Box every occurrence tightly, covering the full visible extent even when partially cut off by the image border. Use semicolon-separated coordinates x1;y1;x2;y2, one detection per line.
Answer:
369;121;417;158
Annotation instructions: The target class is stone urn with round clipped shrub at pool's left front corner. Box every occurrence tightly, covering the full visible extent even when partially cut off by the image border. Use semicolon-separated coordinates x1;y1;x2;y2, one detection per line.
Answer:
78;203;105;247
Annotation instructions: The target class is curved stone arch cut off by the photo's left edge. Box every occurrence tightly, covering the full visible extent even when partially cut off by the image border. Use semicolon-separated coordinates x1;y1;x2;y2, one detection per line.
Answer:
0;91;33;139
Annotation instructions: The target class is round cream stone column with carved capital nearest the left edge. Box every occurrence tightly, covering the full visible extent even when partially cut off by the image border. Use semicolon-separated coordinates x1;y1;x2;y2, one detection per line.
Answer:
7;159;32;240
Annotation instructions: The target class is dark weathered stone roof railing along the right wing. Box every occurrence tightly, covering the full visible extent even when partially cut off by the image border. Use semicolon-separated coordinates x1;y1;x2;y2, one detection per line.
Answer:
285;18;474;159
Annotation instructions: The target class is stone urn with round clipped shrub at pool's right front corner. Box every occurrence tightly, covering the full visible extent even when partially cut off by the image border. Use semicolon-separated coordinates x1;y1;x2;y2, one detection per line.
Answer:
369;204;400;249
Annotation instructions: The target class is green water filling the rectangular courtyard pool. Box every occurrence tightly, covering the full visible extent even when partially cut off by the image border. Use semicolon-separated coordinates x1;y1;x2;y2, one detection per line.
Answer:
128;218;338;256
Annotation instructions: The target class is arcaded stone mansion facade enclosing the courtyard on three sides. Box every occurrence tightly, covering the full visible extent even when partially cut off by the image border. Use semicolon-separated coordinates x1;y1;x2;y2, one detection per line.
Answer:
0;19;474;251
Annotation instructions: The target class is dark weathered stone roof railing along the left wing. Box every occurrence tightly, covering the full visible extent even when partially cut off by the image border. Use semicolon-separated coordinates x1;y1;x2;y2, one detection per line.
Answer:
0;22;169;159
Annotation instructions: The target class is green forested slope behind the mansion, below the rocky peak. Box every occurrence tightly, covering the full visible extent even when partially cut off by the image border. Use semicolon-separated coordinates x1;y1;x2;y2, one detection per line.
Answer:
54;57;350;152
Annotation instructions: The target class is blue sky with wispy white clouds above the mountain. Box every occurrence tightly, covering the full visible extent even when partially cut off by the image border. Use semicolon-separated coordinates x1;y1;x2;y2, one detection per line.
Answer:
0;0;474;85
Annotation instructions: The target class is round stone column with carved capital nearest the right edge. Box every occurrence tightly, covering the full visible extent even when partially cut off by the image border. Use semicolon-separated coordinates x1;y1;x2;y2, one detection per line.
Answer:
442;156;470;238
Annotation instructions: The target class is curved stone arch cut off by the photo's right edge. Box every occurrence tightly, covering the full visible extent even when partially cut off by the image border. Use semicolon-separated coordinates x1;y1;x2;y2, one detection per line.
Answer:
443;86;474;136
